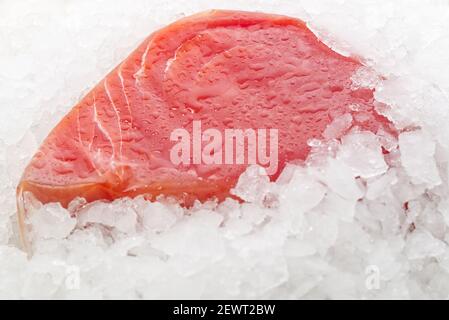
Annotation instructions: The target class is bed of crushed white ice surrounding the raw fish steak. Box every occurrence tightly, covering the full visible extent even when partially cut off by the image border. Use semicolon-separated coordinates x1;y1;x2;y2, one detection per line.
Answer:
0;0;449;299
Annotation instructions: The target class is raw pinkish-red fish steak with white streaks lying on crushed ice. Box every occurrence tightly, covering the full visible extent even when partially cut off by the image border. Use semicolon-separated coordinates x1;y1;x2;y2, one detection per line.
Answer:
18;11;390;223
